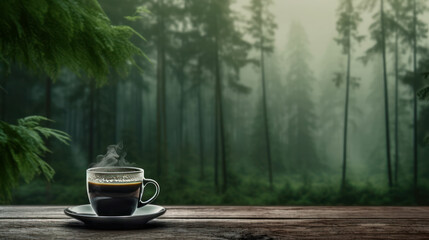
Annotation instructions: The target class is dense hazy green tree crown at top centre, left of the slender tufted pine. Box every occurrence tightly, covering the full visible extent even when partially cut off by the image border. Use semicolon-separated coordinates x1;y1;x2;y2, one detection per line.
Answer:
187;0;251;84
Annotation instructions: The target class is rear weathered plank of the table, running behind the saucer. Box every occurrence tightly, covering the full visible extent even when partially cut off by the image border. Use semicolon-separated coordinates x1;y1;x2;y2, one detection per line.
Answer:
0;206;429;219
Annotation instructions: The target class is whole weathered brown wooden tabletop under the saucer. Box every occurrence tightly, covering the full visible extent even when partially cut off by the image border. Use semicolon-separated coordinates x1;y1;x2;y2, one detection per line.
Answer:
0;206;429;239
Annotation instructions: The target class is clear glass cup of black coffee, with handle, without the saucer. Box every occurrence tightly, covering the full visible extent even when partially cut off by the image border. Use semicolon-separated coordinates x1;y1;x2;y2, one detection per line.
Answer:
86;167;160;216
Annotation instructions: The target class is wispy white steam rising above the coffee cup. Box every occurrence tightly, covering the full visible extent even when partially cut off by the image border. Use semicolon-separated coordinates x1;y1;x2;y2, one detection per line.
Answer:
93;143;132;167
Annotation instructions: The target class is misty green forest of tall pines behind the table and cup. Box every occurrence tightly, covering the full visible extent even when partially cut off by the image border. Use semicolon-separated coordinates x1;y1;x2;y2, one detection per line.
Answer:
0;0;429;205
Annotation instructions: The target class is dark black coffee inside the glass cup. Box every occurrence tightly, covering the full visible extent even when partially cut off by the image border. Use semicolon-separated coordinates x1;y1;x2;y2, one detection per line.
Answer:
88;182;142;216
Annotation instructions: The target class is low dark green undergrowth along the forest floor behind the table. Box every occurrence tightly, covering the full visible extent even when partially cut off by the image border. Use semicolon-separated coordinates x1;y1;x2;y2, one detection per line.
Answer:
12;171;429;205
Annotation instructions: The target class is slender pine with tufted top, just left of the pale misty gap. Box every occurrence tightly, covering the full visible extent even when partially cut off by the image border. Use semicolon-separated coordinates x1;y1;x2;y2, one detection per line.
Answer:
247;0;277;188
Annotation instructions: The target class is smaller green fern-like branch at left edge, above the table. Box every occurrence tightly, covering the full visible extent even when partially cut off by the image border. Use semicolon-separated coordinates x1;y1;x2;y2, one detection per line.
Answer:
0;116;69;202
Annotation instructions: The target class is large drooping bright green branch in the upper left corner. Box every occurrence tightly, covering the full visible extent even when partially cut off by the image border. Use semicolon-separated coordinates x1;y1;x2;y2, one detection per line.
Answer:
0;0;144;84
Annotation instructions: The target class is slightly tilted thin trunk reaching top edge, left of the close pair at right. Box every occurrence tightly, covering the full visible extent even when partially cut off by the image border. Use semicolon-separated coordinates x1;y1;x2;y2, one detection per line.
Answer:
380;0;393;187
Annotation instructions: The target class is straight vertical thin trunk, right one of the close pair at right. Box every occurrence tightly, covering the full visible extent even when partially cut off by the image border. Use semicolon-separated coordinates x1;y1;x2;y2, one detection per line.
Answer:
394;20;399;186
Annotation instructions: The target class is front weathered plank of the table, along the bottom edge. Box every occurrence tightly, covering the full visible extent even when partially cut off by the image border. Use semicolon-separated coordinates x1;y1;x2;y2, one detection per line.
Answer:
0;219;429;239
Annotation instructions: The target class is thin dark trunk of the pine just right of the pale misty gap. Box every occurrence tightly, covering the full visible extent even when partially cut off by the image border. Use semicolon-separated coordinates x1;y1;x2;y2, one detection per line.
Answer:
341;38;351;190
